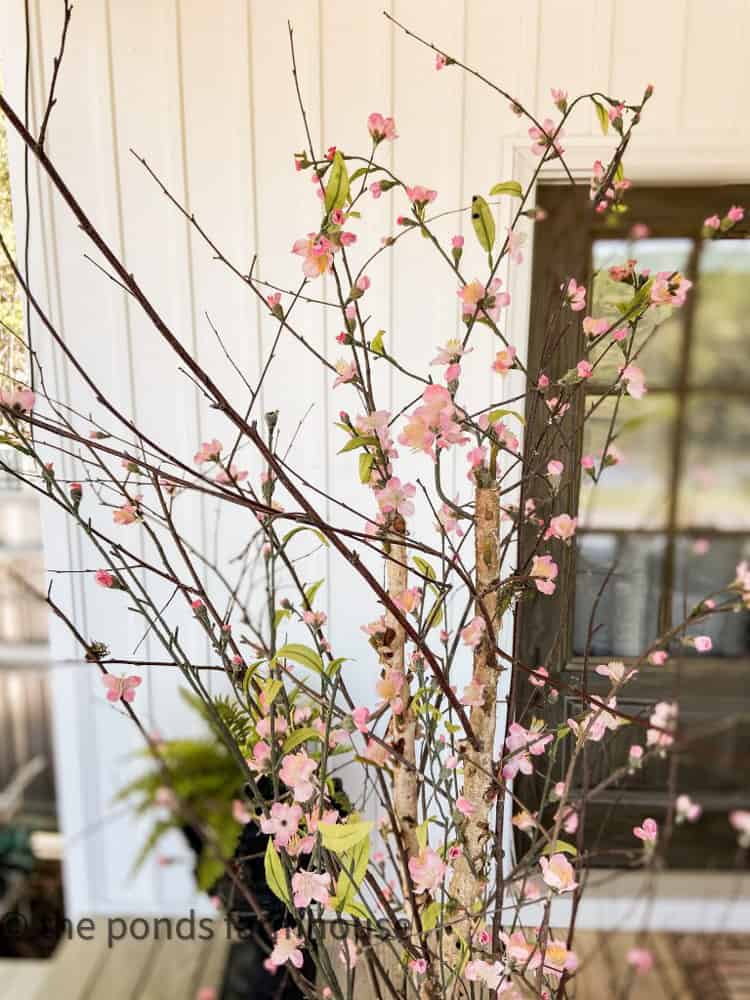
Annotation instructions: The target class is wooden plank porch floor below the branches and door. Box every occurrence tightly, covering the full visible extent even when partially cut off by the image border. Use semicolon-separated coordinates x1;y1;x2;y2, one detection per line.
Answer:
0;922;750;1000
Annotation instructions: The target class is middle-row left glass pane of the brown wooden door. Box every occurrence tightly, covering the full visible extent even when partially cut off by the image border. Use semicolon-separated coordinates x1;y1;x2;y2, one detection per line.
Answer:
578;393;675;529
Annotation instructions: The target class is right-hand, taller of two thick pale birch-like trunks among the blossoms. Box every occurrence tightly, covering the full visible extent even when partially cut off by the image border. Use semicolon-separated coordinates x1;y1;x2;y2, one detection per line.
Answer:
450;487;500;940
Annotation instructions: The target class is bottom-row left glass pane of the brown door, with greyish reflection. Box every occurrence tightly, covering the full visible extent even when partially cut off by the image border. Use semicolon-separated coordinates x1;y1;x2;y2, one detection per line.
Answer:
573;532;665;656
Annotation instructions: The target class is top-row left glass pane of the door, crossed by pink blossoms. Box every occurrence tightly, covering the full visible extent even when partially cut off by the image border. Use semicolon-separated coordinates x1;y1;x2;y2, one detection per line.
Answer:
591;239;693;388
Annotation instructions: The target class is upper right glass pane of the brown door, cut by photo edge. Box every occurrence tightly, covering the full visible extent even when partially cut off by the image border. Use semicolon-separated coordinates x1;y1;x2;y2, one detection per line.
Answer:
690;240;750;387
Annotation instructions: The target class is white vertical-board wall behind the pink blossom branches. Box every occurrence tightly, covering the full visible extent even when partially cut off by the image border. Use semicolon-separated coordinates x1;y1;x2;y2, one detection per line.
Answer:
0;0;750;912
